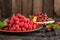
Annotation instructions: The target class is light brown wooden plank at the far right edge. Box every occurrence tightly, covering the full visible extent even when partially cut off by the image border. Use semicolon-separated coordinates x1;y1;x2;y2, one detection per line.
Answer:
54;0;60;18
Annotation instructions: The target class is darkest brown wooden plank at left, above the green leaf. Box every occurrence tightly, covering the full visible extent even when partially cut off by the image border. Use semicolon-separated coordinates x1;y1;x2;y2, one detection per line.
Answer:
2;0;11;18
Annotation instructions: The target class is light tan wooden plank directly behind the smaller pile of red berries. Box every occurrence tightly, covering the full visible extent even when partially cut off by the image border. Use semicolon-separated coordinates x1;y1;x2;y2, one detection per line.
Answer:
33;0;42;14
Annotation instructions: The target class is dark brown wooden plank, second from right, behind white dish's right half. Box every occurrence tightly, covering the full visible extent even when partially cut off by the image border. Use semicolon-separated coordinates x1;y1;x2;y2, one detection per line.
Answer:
44;0;54;17
